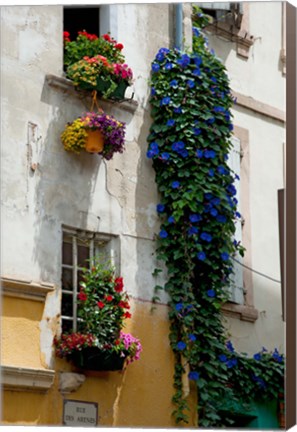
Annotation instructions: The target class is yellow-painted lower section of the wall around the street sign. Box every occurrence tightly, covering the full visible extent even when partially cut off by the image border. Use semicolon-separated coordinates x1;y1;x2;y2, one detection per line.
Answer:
2;298;196;428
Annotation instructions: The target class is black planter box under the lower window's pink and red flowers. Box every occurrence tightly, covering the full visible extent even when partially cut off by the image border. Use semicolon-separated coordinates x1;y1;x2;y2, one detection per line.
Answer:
70;347;126;371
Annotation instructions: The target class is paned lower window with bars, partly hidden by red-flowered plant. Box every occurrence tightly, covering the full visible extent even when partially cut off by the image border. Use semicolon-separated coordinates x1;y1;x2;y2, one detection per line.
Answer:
62;228;119;332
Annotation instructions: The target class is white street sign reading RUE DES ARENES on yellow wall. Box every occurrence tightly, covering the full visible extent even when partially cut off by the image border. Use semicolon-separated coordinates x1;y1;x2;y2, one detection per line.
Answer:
63;400;98;427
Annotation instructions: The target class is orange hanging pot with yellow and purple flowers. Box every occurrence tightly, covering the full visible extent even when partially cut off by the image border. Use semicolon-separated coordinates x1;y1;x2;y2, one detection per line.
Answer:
61;110;125;160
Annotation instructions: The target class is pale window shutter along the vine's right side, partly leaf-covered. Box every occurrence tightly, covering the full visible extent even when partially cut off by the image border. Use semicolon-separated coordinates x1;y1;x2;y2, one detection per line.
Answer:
227;137;244;304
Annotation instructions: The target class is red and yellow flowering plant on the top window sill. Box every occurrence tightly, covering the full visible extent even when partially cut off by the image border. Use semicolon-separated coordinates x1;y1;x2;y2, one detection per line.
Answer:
64;31;133;100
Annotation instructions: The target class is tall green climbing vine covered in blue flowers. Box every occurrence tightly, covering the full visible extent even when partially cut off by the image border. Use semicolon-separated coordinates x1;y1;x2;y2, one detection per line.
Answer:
147;8;284;427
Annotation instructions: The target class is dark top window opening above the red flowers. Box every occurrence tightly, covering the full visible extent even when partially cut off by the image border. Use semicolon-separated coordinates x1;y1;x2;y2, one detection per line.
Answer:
64;6;100;40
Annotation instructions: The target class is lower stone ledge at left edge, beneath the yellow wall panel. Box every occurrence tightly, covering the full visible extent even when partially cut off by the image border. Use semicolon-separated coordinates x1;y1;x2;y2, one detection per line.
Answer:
1;365;55;393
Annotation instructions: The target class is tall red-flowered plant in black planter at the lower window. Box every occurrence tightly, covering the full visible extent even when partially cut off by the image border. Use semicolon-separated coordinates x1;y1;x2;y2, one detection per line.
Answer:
54;260;142;371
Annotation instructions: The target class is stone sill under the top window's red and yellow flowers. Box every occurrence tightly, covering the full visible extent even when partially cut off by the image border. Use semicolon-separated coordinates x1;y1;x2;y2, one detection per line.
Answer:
45;74;138;114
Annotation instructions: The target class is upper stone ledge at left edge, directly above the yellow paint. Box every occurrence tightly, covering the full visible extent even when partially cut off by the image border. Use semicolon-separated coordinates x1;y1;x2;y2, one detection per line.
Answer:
1;277;55;301
